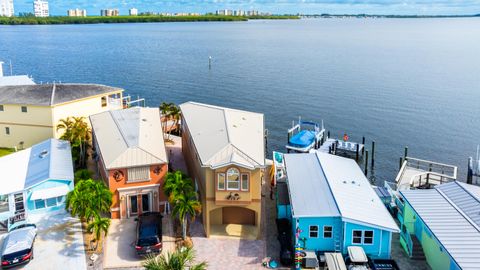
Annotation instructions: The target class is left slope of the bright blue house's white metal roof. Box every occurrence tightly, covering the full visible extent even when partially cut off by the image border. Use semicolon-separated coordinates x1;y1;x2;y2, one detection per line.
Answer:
283;154;340;217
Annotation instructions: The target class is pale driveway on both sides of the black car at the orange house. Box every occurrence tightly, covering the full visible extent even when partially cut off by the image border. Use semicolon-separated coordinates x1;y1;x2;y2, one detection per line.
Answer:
103;215;175;269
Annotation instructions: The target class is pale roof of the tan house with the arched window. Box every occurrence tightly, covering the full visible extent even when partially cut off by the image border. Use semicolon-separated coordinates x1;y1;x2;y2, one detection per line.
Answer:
180;102;265;169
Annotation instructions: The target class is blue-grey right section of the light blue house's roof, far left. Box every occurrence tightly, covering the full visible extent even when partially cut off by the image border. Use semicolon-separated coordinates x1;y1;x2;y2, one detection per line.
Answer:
24;139;73;189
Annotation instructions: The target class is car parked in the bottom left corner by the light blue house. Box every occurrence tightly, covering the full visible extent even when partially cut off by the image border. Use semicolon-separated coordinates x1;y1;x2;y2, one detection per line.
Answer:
1;224;37;269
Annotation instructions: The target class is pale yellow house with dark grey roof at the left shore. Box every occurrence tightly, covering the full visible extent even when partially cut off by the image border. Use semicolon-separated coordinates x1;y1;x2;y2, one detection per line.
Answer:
0;84;123;149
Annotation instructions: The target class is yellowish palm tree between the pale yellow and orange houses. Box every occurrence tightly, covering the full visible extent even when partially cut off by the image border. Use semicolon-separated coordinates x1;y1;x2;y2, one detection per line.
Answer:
57;117;91;167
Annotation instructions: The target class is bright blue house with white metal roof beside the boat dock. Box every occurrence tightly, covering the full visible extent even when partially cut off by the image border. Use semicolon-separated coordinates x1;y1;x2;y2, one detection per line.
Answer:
284;152;399;259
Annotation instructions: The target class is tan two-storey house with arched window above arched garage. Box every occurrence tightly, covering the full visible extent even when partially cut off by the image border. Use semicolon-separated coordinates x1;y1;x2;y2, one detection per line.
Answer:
180;102;265;238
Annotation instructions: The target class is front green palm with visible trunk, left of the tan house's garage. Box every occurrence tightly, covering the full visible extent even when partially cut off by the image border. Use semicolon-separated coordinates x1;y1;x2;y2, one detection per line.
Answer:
172;191;202;239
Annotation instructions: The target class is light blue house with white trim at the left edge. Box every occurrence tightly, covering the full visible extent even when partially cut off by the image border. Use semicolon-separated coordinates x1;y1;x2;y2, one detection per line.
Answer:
0;139;74;228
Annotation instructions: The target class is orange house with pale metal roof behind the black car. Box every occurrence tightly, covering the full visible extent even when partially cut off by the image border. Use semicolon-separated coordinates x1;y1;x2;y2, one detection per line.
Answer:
90;107;168;219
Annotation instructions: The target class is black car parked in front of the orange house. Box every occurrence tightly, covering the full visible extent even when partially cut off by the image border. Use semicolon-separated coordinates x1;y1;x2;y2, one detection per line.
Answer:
135;212;162;256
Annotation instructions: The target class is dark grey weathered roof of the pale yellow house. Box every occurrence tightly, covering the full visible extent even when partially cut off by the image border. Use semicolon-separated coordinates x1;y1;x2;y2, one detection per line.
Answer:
0;84;123;106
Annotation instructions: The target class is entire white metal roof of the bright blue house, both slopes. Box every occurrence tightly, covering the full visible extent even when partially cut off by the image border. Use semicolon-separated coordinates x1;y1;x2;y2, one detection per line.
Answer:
284;152;399;232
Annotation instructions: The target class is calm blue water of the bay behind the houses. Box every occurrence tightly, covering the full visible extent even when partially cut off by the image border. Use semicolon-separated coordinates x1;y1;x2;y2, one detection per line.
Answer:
0;18;480;183
